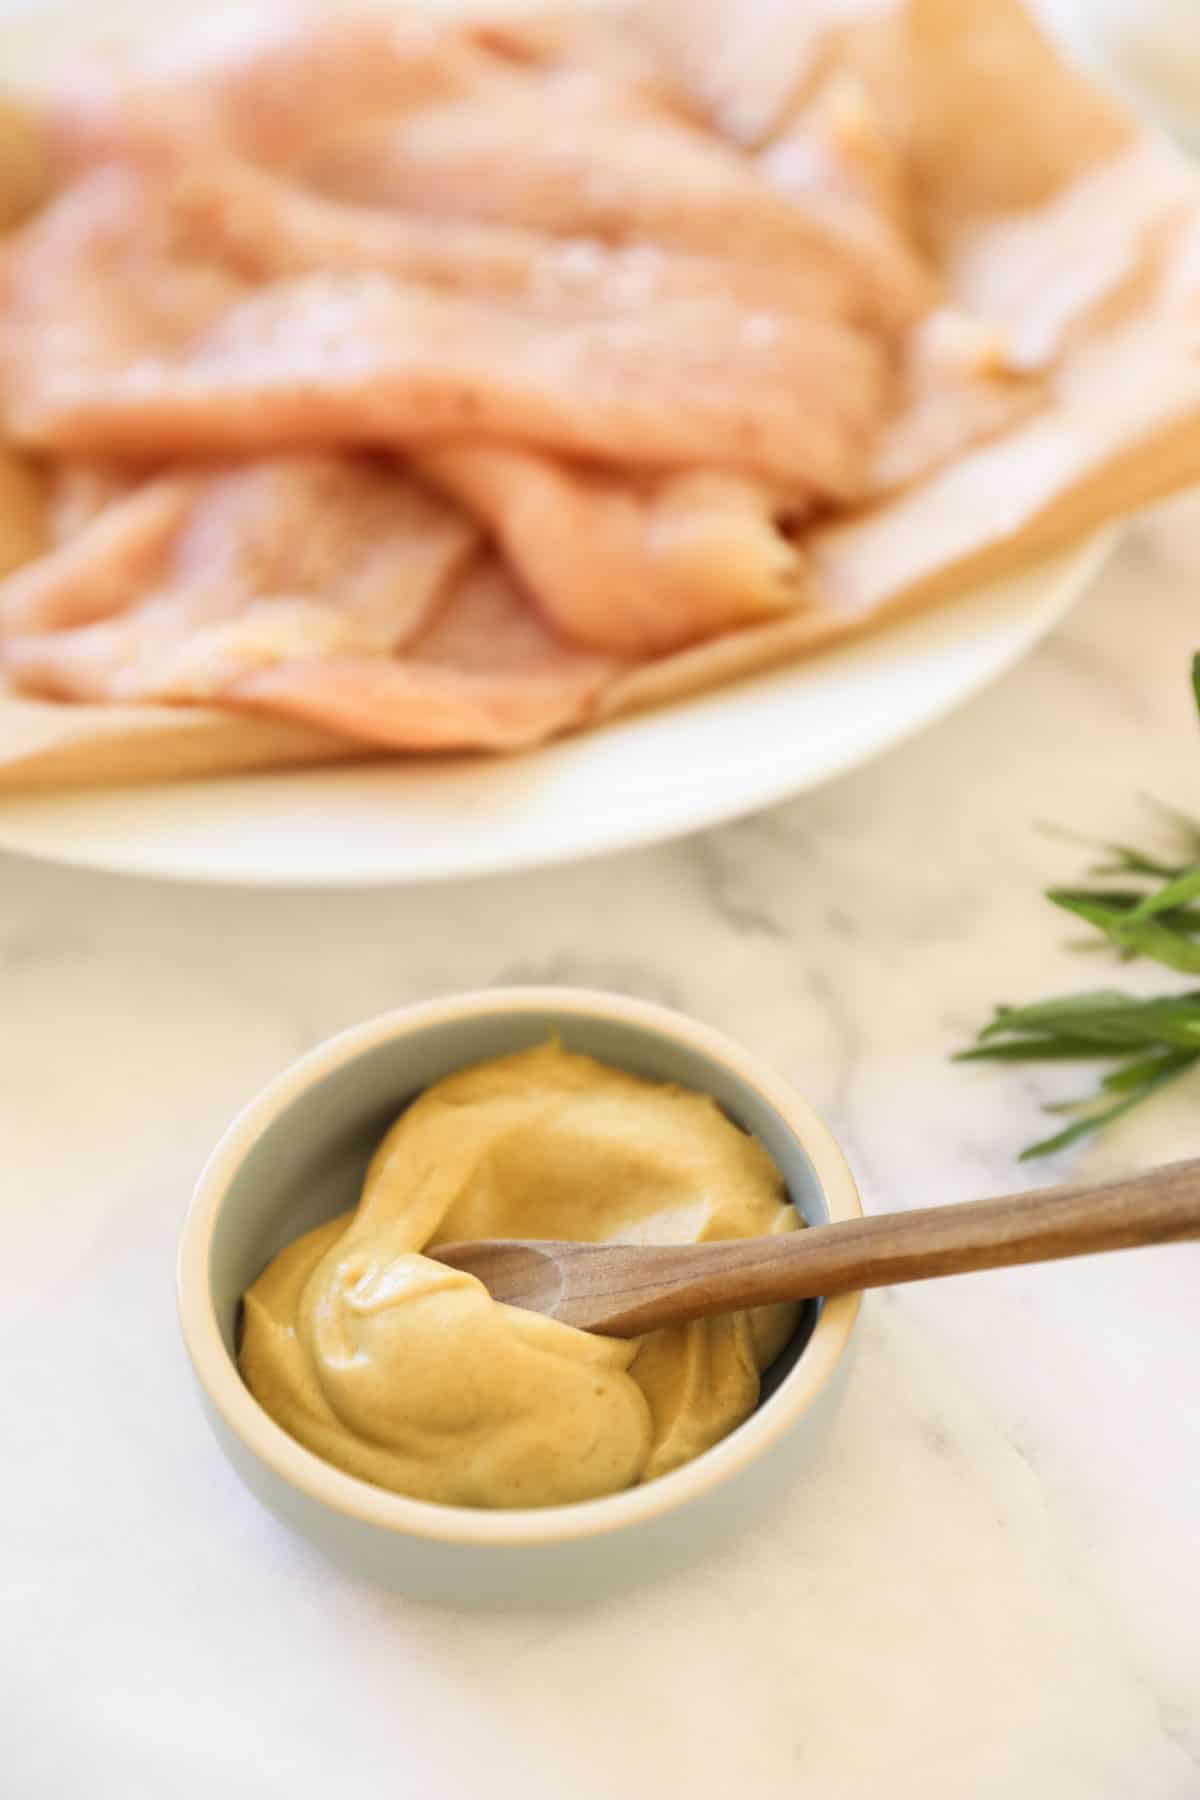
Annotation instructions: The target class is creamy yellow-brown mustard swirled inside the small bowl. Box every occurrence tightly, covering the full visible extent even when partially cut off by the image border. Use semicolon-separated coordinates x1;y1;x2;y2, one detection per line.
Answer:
239;1044;799;1507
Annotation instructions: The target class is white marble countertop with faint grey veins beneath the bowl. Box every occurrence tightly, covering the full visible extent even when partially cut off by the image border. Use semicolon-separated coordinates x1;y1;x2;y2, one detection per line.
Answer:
0;500;1200;1800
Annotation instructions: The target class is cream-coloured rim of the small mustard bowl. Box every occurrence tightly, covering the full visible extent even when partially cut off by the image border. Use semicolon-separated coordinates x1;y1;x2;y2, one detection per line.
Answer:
176;986;862;1548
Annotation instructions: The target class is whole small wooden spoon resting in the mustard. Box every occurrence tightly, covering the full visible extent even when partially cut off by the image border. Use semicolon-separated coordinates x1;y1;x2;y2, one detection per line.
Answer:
426;1159;1200;1337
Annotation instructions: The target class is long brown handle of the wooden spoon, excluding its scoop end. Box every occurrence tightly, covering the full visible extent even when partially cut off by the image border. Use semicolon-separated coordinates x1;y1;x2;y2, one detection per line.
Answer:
581;1159;1200;1336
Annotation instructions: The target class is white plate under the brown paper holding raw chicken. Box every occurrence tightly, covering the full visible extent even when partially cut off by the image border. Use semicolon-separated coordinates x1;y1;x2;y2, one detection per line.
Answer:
0;529;1115;887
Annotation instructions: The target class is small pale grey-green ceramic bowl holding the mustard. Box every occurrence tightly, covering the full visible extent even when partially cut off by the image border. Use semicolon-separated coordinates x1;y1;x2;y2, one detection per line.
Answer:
178;988;862;1604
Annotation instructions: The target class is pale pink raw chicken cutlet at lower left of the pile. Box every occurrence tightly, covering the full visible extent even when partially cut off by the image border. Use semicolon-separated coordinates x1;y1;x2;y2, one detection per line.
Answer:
0;457;613;749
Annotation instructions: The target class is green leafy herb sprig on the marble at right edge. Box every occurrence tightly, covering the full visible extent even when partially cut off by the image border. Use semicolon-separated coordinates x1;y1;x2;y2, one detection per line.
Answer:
955;653;1200;1161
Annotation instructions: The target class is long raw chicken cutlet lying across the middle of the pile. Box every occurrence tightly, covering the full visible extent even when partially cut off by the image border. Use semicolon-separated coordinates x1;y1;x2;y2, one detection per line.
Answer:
0;166;889;495
